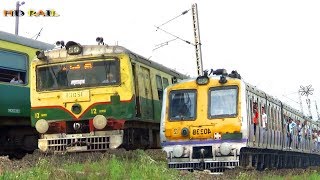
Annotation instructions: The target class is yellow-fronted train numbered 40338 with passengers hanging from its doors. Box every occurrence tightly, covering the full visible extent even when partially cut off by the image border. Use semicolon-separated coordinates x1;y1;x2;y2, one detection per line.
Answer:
160;69;320;172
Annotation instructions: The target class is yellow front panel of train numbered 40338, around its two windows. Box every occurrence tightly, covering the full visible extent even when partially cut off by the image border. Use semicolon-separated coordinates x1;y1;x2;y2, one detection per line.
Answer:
165;78;242;139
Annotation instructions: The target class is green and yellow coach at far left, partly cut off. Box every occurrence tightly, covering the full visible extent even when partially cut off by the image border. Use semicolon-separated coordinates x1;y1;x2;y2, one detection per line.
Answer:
0;31;53;158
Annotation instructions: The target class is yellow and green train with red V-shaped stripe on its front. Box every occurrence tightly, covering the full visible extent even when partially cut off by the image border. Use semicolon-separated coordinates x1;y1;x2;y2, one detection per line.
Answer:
30;38;186;152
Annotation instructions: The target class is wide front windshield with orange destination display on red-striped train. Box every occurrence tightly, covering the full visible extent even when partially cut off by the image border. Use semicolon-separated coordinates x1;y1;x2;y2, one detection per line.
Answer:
37;59;120;91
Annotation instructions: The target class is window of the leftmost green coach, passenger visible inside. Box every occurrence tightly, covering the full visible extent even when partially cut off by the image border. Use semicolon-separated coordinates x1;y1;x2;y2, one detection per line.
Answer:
0;50;28;84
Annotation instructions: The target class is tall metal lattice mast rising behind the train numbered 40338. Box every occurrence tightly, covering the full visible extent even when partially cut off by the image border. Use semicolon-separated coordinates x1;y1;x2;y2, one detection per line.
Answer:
192;3;203;76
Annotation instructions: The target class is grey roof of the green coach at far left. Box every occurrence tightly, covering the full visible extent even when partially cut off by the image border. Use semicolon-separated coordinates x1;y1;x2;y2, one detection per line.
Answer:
0;31;54;50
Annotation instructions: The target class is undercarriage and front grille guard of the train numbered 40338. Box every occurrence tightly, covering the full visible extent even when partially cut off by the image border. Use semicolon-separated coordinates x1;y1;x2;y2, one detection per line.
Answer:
168;147;320;173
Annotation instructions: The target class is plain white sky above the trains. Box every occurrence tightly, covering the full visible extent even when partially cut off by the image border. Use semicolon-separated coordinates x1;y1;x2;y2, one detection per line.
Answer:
0;0;320;119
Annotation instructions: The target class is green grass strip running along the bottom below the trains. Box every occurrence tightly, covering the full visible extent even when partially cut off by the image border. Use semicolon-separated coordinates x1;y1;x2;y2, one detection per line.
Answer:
0;150;320;180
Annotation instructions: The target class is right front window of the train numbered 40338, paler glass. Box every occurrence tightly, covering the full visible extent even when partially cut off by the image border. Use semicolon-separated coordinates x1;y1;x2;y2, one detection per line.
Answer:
208;86;238;118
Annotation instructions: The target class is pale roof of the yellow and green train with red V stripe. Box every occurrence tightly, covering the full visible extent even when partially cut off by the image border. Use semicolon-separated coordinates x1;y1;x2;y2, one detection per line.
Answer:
45;45;189;79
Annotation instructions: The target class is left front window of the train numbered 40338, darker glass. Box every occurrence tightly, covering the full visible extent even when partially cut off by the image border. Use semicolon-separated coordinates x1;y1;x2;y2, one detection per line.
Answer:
169;90;196;121
